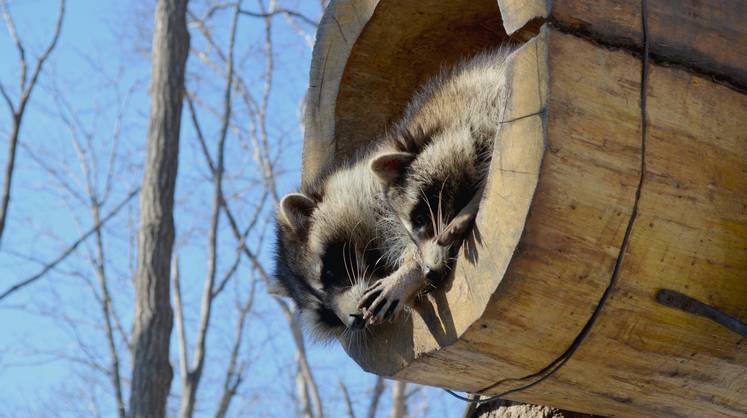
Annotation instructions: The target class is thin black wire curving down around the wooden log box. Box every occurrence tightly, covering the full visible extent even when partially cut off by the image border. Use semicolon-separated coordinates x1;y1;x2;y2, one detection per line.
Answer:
444;0;649;404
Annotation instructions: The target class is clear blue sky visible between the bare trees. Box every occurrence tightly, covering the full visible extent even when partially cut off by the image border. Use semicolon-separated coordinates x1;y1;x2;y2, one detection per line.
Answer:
0;0;463;417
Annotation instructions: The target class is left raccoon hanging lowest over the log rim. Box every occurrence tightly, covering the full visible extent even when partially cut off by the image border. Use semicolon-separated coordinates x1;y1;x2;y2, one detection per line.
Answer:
275;142;430;339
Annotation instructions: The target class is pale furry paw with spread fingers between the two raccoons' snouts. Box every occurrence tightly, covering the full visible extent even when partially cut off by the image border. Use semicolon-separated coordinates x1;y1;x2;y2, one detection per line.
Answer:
358;260;426;324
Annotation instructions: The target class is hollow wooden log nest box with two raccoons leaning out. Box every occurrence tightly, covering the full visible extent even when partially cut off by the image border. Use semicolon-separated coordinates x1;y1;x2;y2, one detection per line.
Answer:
303;0;747;417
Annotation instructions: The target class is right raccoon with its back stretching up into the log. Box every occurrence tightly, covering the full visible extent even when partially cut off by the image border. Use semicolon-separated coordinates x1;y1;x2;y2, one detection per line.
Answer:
370;46;514;284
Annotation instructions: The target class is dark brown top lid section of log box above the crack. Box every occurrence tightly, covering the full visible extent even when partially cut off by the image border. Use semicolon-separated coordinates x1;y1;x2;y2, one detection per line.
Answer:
498;0;747;91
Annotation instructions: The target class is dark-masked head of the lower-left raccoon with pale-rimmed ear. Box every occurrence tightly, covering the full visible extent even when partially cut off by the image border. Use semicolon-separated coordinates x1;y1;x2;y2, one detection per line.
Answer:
277;193;382;339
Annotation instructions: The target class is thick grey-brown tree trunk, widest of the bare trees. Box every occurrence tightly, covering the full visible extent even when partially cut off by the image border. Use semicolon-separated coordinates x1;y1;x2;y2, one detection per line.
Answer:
130;0;189;418
